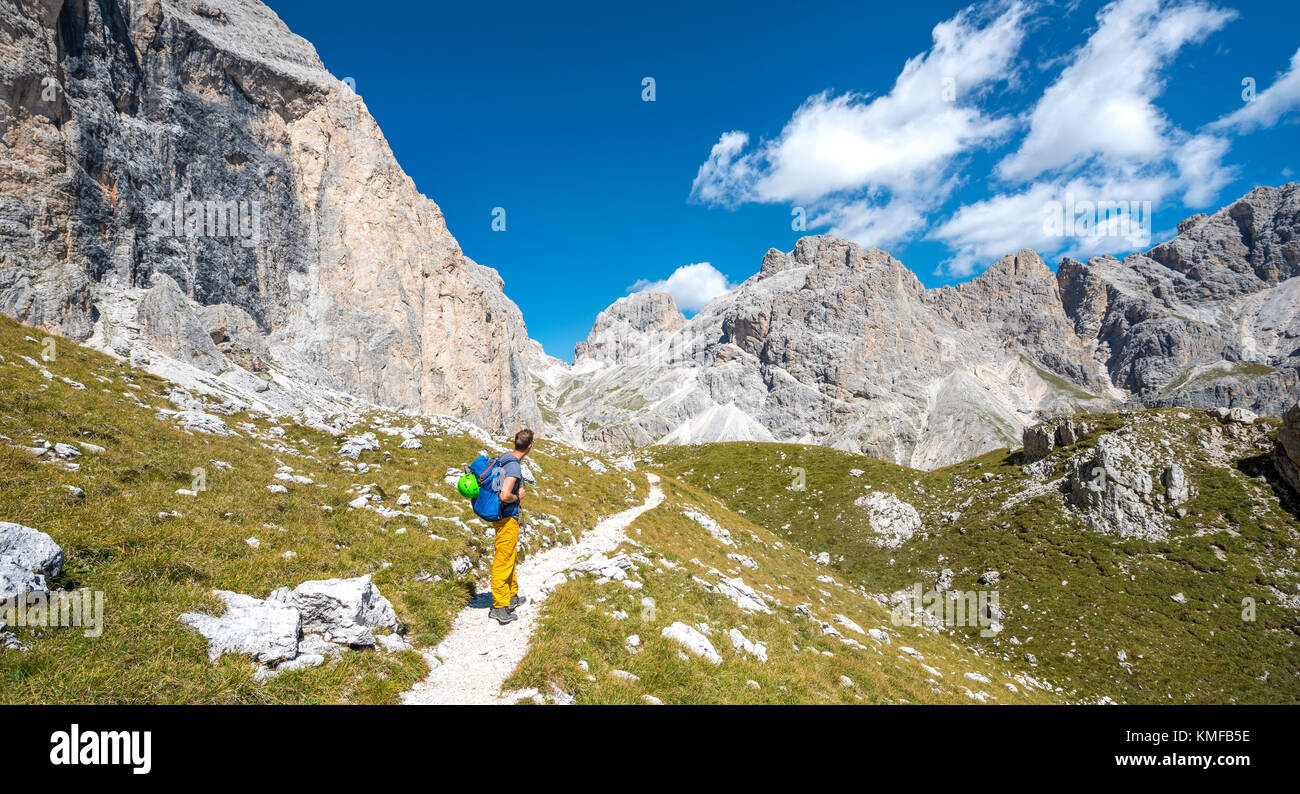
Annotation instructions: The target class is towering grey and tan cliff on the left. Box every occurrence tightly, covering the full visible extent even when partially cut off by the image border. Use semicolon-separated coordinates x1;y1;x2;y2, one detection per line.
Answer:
0;0;540;430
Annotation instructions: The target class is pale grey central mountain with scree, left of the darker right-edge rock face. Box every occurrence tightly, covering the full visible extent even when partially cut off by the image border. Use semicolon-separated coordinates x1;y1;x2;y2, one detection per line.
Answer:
538;235;1112;468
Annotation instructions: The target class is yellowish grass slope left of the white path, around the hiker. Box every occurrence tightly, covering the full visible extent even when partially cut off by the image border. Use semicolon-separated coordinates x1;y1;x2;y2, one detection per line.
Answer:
0;317;646;703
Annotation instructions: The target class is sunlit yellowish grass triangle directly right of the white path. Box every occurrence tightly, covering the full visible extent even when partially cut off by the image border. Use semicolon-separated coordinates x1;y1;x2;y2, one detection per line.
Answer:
507;480;1056;703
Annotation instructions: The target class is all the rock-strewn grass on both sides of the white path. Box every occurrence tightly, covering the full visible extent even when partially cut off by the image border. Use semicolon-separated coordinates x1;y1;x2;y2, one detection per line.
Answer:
0;313;1300;703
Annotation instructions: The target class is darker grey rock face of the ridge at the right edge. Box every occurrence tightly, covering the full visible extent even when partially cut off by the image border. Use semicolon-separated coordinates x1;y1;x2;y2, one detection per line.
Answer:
1057;183;1300;416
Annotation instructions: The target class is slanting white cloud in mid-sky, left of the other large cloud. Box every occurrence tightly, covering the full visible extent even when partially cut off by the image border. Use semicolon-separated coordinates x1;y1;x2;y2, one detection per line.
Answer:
692;0;1026;244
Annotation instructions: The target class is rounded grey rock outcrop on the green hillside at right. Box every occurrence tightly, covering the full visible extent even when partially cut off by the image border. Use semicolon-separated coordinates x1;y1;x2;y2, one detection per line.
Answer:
1069;433;1169;541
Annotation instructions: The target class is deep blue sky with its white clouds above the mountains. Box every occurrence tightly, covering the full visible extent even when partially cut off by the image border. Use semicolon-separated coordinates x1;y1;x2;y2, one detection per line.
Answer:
268;0;1300;360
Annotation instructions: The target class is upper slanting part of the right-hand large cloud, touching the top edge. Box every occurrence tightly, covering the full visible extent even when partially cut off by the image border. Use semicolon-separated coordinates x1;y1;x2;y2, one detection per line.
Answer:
997;0;1236;179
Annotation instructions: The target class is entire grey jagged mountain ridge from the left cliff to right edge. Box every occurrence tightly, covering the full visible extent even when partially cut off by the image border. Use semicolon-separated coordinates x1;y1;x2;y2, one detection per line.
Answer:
533;183;1300;468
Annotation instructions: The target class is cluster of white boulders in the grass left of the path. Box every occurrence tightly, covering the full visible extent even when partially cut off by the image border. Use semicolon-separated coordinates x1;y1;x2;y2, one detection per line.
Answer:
181;574;410;681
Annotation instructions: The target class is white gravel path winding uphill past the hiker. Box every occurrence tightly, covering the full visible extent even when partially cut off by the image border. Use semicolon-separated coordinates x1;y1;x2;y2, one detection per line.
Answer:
402;473;663;706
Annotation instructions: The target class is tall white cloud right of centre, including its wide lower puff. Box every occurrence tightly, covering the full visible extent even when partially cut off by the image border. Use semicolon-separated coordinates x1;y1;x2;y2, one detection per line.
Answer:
931;0;1235;275
